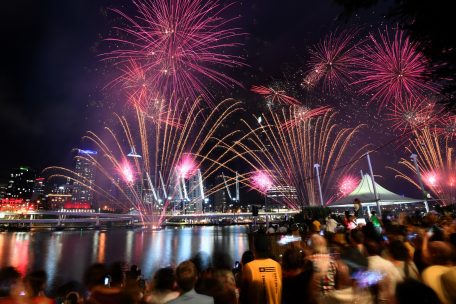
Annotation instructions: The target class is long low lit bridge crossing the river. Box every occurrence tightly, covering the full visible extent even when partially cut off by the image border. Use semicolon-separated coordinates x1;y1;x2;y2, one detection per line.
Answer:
0;209;298;227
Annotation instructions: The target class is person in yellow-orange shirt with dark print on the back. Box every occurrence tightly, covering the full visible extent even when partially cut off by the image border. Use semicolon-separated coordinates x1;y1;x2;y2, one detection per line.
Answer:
240;234;282;304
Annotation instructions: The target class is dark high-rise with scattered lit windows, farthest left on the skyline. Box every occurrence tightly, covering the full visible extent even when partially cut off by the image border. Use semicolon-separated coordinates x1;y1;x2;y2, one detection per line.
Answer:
6;166;35;202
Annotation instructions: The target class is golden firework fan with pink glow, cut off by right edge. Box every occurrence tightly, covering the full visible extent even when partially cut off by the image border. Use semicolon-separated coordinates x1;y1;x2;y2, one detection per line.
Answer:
392;128;456;204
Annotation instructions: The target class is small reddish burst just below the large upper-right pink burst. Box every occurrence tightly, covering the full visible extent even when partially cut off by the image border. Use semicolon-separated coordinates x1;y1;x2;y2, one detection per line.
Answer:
387;98;440;132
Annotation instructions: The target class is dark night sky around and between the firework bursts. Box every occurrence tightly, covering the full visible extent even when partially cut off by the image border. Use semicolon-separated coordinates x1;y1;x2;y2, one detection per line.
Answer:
0;0;416;197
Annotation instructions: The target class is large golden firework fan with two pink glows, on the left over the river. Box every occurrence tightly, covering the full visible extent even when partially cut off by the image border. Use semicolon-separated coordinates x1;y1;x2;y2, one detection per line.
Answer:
46;100;241;225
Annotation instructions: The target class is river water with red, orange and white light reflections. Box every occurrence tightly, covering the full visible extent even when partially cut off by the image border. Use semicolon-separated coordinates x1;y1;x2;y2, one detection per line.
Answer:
0;226;248;286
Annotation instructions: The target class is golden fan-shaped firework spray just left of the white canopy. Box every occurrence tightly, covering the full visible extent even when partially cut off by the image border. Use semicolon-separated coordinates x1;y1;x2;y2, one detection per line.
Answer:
232;109;366;208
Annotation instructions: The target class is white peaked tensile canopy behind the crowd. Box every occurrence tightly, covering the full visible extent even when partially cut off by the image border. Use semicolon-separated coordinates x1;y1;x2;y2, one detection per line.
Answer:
329;174;423;207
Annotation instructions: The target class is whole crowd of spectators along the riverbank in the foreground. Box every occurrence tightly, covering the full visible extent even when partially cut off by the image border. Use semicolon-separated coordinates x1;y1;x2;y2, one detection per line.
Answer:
0;203;456;304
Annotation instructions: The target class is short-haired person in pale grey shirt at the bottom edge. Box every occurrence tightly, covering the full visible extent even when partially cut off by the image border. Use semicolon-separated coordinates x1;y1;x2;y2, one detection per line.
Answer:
168;261;214;304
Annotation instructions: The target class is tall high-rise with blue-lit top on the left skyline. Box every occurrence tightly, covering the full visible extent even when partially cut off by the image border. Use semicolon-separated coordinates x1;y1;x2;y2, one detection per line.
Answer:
72;149;97;204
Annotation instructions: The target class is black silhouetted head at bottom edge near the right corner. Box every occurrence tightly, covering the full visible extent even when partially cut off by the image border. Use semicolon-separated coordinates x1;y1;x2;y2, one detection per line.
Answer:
395;279;440;304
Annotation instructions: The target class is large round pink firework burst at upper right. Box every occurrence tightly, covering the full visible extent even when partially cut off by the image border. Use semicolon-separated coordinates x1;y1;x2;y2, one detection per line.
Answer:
353;29;436;106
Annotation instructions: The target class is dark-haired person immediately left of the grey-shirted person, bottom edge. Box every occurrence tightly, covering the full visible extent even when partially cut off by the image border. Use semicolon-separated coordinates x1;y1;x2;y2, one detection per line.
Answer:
147;267;179;304
